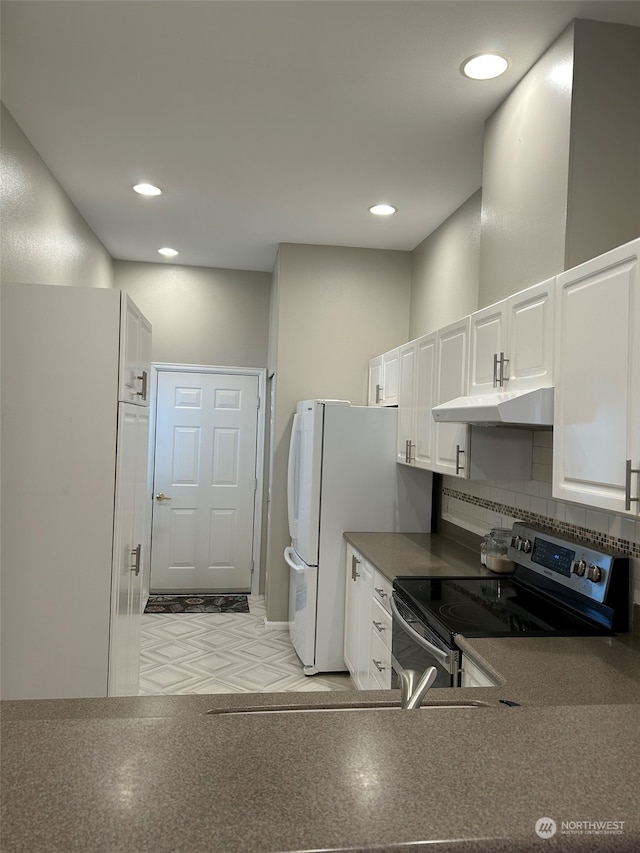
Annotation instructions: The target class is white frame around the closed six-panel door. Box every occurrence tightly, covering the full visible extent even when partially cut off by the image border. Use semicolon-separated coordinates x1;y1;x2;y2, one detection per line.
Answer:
142;362;267;609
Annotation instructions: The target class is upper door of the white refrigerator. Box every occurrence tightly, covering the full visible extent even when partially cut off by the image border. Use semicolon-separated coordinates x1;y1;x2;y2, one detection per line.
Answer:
287;400;324;566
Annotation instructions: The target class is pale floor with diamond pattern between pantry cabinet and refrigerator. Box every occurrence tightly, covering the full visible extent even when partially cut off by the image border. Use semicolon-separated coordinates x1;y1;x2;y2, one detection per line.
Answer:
140;596;351;696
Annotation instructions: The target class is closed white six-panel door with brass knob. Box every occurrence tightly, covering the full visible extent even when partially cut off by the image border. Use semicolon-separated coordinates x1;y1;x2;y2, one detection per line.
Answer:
151;371;258;593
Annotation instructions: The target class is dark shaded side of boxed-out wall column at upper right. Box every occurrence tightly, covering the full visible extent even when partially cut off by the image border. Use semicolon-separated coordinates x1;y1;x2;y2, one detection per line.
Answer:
565;21;640;269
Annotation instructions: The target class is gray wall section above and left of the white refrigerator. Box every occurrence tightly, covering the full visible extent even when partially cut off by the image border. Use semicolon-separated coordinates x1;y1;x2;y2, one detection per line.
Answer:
265;244;411;621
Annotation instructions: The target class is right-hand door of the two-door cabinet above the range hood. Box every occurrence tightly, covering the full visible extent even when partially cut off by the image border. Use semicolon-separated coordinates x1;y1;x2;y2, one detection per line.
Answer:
505;278;556;391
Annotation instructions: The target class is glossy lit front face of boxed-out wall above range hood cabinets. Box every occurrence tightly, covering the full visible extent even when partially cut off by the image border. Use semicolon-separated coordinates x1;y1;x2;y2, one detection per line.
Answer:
478;25;573;308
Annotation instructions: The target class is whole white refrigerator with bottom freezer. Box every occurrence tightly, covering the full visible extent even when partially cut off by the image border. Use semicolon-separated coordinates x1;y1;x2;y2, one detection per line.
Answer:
284;400;432;675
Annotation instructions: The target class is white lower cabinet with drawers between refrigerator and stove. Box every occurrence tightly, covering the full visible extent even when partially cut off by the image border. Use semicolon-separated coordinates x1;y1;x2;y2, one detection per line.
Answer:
344;544;391;690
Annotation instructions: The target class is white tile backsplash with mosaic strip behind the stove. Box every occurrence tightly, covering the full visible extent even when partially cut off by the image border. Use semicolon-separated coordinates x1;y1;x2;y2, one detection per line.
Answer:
442;431;640;604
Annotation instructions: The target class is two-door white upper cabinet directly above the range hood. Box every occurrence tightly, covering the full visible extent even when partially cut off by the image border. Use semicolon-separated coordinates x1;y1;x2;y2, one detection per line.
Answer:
469;278;555;396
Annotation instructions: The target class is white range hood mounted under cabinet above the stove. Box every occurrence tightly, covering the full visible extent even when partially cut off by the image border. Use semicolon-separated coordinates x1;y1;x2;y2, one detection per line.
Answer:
431;388;553;427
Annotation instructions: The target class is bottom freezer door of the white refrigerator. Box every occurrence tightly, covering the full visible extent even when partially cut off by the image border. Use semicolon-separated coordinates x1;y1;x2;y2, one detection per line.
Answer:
284;548;318;675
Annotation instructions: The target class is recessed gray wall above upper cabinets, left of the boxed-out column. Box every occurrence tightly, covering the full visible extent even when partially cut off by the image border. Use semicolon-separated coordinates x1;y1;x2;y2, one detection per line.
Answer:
409;190;482;340
